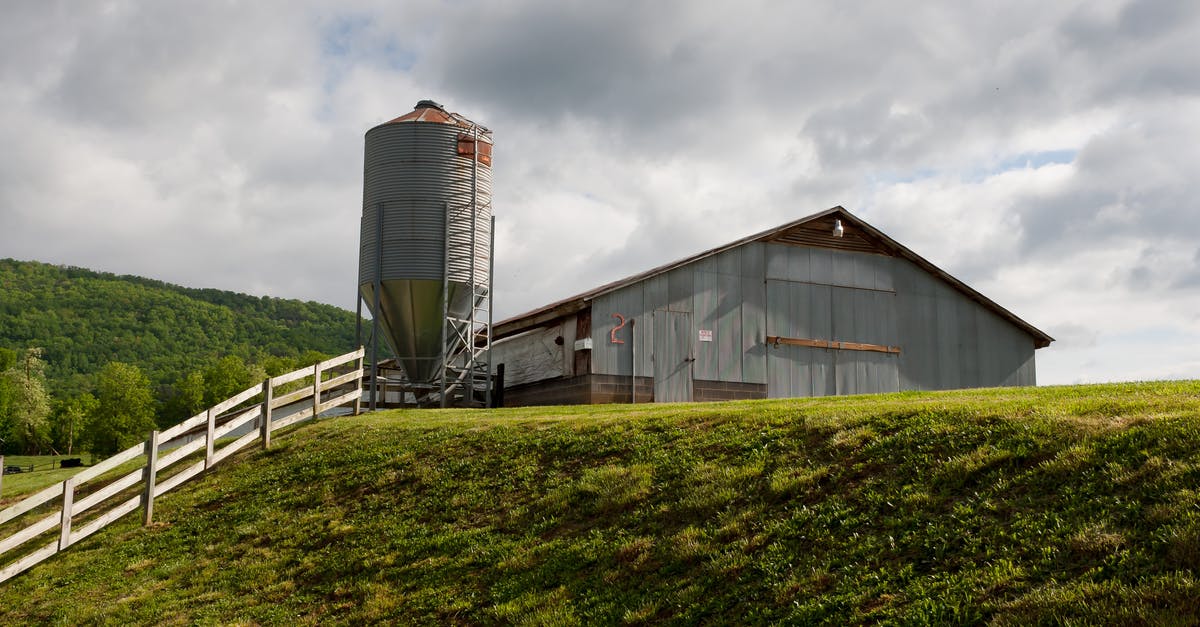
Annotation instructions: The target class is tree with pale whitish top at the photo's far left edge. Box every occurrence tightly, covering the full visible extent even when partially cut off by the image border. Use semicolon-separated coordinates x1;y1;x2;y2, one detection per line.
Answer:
4;348;50;454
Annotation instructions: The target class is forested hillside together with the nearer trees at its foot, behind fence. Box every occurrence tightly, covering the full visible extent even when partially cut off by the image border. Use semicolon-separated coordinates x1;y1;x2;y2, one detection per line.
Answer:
0;259;354;452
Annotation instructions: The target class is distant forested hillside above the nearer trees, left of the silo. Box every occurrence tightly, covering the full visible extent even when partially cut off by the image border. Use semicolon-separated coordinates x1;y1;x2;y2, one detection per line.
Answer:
0;259;354;390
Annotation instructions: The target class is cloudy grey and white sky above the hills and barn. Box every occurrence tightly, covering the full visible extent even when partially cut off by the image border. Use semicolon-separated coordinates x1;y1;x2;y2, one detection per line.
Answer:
0;0;1200;383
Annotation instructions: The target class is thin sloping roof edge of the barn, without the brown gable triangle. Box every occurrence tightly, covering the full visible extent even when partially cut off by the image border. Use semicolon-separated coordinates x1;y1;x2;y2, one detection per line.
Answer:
493;205;1054;348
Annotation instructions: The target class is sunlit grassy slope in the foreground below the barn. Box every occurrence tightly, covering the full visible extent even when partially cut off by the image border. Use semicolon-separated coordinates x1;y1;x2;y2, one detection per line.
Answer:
0;382;1200;625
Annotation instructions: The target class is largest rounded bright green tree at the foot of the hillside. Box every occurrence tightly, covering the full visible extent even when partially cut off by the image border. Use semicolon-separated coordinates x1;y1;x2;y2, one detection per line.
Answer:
86;362;155;455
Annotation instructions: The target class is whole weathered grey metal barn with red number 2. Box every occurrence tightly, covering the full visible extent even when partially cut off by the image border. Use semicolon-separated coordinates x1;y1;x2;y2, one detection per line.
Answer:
492;207;1054;406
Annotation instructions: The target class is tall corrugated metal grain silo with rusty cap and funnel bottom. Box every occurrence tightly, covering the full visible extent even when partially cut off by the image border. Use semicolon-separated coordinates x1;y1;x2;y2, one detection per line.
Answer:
359;100;492;402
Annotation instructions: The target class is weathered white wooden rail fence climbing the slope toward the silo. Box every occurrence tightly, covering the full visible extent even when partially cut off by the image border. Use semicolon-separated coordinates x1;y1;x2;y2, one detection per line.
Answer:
0;347;364;583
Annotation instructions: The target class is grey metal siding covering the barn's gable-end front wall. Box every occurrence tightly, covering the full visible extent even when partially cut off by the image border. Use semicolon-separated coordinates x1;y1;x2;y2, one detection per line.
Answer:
593;243;1034;396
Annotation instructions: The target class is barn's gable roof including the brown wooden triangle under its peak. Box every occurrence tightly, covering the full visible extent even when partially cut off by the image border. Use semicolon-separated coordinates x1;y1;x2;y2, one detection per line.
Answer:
492;207;1054;348
